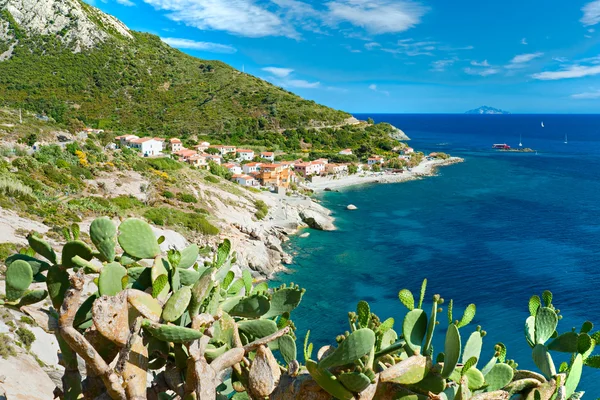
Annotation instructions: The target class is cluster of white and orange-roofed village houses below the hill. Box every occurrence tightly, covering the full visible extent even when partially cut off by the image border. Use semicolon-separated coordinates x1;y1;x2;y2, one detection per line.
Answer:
111;134;437;192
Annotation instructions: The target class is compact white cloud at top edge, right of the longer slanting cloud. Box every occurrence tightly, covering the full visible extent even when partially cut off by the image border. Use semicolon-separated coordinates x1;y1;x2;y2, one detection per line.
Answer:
325;0;428;34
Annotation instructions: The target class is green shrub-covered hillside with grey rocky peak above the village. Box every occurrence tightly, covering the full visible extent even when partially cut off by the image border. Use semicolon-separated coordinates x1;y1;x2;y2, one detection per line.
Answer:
0;0;350;137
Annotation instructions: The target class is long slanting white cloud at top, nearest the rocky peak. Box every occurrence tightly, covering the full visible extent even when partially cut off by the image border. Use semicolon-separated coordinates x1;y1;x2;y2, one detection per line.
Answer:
144;0;298;38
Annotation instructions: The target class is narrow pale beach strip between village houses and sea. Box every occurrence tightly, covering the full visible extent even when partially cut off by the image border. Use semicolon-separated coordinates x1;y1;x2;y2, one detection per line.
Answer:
305;157;464;192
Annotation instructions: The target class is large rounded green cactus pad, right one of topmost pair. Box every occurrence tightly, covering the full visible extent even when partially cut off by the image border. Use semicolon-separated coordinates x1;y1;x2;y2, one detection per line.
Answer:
118;218;160;258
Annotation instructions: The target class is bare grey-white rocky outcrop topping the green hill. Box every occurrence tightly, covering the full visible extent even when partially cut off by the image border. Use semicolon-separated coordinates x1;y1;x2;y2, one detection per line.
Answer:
0;0;133;52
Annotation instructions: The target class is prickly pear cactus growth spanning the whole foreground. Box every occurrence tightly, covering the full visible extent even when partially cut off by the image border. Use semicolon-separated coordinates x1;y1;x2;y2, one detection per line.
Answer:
0;218;600;400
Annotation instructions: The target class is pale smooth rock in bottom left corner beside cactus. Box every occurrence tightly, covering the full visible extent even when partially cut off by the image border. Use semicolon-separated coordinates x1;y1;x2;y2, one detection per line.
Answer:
0;352;55;400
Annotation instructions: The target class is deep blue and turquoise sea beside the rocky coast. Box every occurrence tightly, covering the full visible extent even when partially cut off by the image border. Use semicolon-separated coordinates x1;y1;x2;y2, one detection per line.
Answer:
277;114;600;399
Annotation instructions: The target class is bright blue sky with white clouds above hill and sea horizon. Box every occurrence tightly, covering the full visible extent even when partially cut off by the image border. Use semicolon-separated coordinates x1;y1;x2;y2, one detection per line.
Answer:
87;0;600;113
